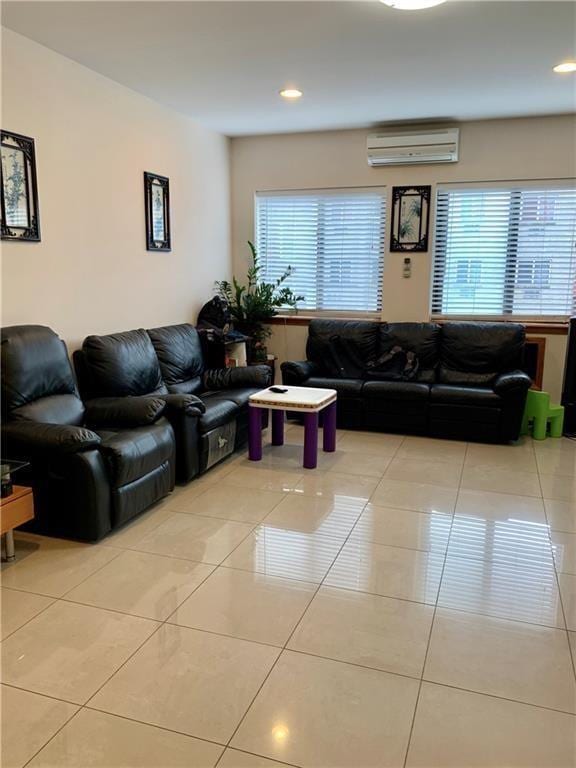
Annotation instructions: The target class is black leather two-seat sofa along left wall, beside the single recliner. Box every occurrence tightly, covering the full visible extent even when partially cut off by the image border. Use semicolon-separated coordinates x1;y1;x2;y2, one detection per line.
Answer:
74;324;271;482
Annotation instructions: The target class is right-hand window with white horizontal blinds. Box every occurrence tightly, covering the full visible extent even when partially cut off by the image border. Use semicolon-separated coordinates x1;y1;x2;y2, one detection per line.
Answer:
432;184;576;320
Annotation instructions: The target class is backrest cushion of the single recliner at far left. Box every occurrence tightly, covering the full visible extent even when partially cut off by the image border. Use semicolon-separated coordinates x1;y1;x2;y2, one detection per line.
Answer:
2;325;84;425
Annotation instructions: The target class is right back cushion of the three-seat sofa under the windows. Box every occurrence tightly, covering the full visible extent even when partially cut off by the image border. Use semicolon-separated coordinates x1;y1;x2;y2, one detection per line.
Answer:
438;323;525;386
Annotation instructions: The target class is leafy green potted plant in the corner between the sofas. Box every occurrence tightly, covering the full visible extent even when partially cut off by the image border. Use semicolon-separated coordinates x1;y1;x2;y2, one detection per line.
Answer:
216;241;304;363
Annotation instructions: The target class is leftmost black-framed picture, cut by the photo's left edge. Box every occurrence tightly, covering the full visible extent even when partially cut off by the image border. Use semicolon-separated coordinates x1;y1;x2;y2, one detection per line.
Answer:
0;131;40;242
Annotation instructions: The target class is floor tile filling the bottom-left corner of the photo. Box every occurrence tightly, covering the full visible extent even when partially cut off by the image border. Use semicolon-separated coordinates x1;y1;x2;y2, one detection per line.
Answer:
0;685;78;768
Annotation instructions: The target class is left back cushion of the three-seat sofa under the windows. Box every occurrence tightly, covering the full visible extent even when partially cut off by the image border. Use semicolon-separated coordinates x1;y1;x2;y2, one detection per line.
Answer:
306;320;380;378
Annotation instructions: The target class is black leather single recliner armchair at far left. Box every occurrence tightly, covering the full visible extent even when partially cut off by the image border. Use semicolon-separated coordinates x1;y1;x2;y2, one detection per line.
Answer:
2;326;174;541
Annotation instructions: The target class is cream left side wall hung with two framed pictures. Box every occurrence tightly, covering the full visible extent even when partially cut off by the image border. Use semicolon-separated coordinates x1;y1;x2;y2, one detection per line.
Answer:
2;29;230;347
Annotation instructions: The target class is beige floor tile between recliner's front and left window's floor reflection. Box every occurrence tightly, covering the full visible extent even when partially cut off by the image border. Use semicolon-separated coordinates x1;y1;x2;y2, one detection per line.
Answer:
134;512;254;565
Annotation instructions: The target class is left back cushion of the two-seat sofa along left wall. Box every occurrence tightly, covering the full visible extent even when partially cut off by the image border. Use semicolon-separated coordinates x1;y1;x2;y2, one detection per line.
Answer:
74;328;168;398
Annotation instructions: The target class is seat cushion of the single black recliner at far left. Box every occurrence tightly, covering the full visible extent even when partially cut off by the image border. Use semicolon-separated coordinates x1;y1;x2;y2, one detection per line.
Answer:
97;419;174;486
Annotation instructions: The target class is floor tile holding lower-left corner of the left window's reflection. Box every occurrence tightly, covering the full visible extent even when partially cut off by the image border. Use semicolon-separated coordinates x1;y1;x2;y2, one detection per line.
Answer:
222;525;342;584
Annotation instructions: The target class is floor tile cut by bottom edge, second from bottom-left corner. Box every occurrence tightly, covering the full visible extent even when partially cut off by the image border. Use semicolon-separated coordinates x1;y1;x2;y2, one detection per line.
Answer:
29;709;222;768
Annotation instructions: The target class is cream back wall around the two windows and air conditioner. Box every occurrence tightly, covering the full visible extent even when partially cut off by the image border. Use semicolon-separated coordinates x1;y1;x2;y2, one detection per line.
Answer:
232;115;576;399
